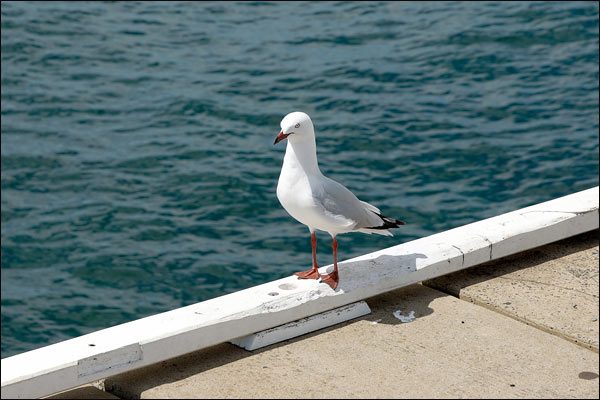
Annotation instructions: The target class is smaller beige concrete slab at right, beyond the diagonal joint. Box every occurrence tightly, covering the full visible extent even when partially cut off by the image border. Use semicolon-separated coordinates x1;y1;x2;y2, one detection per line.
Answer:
423;231;600;352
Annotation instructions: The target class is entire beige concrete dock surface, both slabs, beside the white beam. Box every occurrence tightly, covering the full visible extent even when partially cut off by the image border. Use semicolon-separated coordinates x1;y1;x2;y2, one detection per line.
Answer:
51;230;599;399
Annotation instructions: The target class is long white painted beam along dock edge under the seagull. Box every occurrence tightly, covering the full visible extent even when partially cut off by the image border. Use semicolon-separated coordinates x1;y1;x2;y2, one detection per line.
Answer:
2;187;598;398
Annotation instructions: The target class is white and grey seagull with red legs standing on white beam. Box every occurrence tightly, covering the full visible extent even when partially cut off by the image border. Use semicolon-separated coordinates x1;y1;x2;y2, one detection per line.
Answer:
273;111;405;290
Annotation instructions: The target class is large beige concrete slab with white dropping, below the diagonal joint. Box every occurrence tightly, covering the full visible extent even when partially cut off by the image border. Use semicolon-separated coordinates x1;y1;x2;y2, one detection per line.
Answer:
105;284;598;399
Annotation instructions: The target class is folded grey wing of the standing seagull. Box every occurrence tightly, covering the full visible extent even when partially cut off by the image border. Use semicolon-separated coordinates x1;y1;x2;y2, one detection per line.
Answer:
319;177;382;230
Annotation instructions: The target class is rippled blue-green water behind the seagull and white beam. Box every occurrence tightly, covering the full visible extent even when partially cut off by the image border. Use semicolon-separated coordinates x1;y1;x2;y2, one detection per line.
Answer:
1;2;599;357
